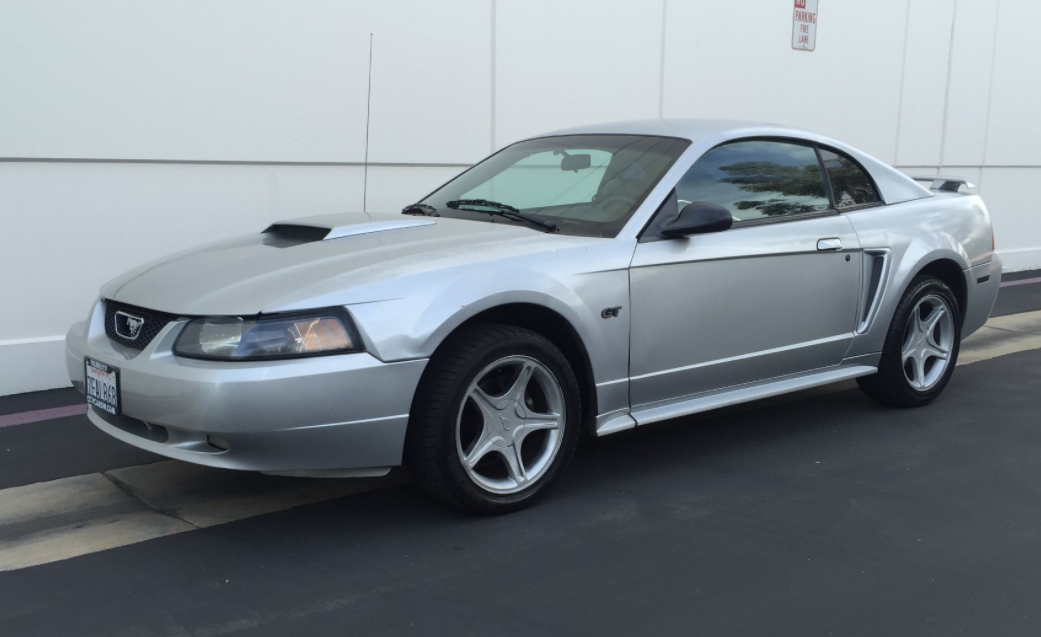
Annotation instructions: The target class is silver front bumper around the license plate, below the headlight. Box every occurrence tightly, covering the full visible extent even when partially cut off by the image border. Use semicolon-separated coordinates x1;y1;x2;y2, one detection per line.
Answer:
66;301;427;472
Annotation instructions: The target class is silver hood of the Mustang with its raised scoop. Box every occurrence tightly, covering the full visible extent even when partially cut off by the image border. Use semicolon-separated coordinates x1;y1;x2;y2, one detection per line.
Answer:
101;212;604;315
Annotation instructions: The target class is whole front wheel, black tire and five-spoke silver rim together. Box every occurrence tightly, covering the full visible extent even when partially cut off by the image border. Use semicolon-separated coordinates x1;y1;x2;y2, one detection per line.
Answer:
405;325;582;514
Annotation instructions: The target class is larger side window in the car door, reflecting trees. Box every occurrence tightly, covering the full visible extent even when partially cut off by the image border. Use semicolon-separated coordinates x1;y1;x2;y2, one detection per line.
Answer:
676;142;831;222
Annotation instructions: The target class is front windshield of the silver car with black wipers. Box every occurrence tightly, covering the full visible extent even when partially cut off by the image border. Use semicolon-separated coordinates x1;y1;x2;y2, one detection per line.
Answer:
421;135;689;237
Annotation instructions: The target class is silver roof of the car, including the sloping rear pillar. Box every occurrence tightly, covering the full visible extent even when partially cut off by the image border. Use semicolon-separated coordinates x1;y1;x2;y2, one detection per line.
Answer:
529;119;933;204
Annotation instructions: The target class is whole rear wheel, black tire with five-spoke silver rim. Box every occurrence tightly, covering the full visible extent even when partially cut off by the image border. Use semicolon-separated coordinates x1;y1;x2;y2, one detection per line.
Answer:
857;276;961;407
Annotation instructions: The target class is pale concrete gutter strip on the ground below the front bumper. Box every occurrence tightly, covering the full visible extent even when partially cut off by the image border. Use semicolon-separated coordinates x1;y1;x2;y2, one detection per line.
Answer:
0;460;406;571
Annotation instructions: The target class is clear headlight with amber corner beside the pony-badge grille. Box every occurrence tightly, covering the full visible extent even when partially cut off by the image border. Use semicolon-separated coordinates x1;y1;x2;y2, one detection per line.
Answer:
174;308;361;360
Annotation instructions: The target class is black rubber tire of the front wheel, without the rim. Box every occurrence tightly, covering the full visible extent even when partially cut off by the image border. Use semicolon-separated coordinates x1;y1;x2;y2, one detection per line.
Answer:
405;325;582;515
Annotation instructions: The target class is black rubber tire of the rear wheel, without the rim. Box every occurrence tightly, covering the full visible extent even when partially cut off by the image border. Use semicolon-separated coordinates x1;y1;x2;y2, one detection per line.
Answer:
857;275;962;407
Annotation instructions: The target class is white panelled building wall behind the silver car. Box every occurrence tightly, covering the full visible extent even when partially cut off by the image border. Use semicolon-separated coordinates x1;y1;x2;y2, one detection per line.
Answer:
0;0;1041;394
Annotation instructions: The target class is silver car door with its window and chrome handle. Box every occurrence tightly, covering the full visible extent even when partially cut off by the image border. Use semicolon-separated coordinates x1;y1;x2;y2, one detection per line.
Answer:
630;141;861;408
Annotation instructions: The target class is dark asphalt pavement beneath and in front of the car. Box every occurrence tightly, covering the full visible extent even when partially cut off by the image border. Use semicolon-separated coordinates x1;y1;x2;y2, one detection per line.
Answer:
0;277;1041;637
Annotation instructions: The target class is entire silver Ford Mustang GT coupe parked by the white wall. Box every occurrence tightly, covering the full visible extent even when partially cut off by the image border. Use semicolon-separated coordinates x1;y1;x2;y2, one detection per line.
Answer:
66;121;1001;513
